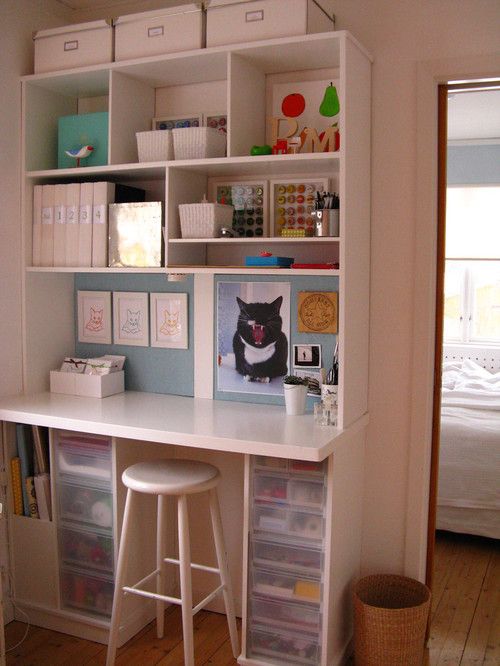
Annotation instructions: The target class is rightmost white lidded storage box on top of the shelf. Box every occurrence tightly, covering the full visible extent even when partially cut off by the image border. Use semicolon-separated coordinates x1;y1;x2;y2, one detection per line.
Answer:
207;0;335;46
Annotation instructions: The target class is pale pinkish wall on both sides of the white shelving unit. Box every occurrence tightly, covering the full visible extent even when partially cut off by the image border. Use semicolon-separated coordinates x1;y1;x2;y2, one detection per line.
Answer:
0;0;500;596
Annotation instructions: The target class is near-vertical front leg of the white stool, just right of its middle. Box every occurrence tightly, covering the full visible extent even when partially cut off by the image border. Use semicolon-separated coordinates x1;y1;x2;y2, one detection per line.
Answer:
177;495;194;666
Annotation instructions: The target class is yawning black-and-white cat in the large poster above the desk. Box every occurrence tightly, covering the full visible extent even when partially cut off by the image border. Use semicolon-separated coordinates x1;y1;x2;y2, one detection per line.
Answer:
233;296;288;383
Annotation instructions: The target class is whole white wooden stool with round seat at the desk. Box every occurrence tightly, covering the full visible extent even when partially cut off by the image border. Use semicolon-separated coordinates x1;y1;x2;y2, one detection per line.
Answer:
106;460;239;666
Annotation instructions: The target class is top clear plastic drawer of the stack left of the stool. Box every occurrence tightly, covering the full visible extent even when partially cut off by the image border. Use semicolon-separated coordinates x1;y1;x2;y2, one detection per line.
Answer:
56;432;112;485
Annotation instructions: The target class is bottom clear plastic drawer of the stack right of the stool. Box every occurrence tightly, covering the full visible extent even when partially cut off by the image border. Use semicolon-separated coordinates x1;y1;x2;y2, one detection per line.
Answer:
249;628;320;664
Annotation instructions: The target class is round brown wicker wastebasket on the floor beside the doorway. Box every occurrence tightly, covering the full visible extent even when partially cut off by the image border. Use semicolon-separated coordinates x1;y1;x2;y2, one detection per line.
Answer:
354;574;431;666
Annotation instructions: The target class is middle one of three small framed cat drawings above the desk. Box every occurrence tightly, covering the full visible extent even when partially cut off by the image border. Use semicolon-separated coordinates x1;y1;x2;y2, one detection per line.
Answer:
113;291;149;347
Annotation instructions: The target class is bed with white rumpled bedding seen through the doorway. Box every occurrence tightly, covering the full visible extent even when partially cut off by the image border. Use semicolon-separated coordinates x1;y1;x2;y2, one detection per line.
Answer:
436;347;500;539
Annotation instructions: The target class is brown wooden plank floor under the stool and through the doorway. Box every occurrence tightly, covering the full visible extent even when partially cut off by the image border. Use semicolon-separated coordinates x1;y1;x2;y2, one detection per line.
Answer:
6;532;500;666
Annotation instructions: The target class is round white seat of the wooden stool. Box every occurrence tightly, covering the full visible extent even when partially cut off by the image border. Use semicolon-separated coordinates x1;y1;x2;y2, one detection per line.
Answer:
122;459;220;495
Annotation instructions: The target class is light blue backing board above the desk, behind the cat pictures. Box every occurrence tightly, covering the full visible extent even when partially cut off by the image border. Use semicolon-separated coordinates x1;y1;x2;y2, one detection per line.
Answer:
75;273;339;403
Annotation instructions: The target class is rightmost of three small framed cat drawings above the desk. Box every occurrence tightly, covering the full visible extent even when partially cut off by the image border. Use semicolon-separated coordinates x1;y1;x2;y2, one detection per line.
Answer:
149;292;188;349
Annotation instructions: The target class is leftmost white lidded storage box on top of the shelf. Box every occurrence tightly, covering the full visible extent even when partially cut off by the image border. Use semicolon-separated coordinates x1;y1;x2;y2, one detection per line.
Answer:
33;20;113;74
